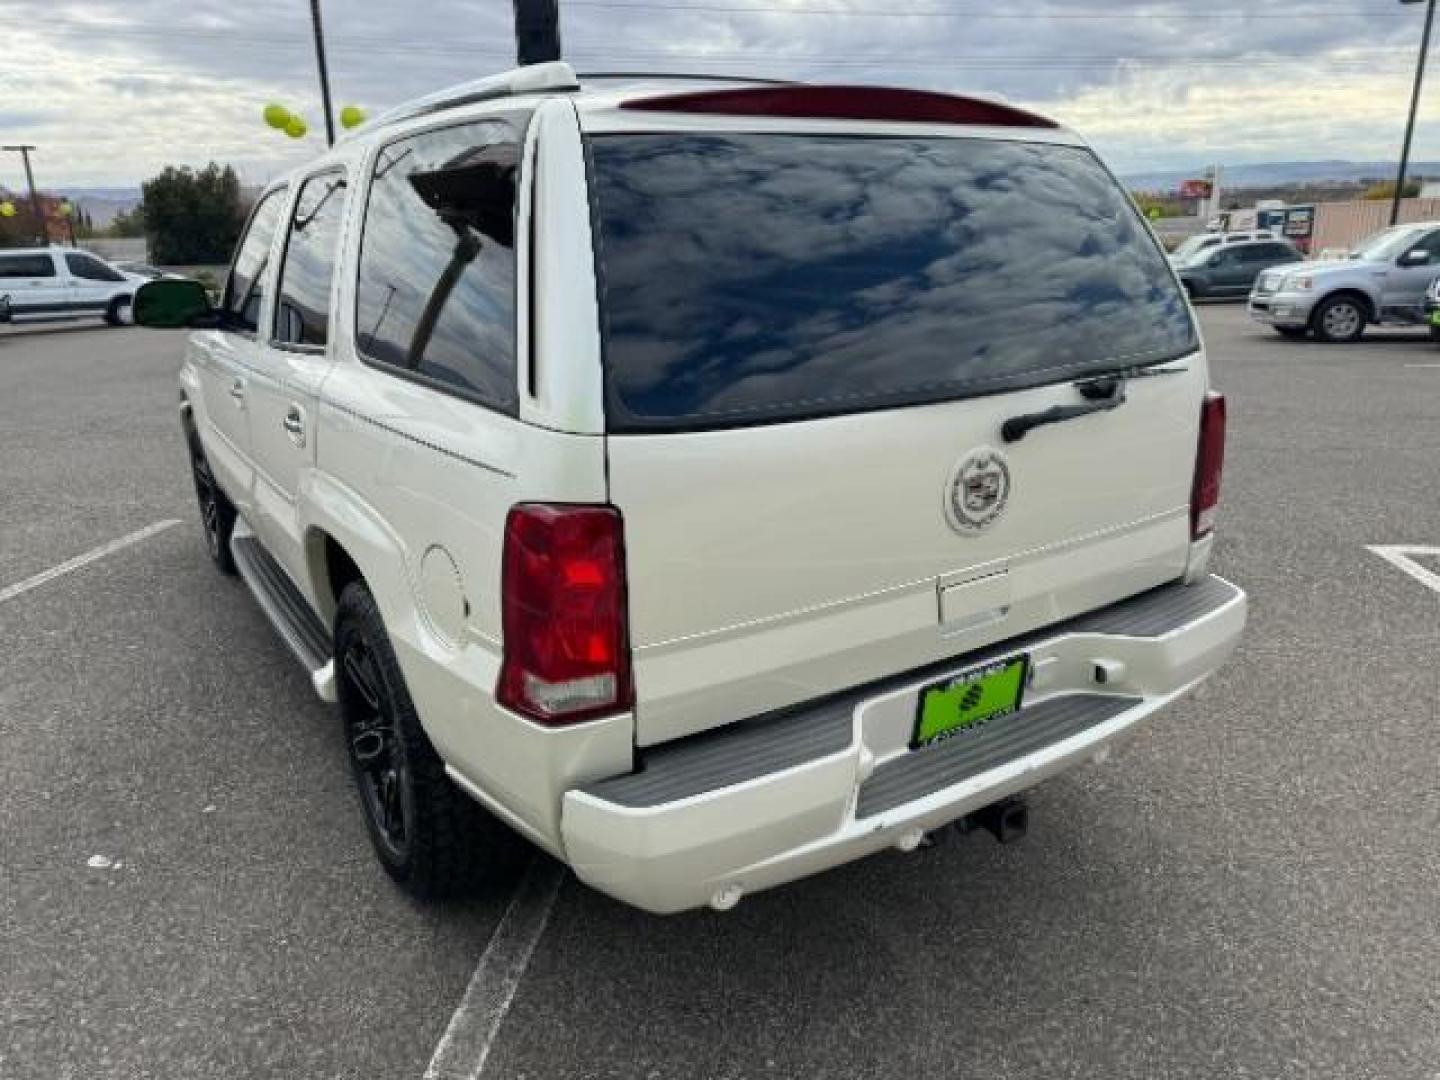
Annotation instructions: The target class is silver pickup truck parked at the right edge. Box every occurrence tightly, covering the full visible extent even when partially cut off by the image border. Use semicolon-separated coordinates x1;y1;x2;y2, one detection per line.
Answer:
1250;222;1440;341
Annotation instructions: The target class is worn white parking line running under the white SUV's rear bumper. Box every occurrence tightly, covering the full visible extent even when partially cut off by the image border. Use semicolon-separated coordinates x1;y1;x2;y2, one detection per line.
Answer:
423;855;564;1080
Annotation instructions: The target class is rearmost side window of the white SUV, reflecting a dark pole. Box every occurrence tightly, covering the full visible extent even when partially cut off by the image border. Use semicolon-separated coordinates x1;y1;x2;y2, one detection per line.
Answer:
356;121;521;413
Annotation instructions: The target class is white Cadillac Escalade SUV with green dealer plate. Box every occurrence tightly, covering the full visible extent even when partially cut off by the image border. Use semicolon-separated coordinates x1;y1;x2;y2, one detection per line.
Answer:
135;62;1246;912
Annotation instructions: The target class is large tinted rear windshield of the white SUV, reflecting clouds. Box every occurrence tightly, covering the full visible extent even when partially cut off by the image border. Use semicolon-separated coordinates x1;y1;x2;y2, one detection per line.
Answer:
590;134;1197;432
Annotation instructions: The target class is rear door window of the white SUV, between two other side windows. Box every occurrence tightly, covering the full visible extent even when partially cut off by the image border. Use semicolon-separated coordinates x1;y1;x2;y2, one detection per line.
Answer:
275;173;346;347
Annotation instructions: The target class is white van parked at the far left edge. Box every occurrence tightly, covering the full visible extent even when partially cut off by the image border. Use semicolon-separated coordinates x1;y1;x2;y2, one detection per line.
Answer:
0;248;145;327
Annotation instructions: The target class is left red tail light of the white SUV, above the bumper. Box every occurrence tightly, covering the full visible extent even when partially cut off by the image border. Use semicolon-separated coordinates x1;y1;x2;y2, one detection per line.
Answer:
495;503;635;724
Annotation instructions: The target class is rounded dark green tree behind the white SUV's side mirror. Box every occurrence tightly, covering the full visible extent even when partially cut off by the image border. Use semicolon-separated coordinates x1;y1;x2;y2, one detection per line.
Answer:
138;161;245;266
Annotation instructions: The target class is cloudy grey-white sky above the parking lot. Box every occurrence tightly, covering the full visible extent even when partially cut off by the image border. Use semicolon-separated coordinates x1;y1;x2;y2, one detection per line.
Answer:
0;0;1440;187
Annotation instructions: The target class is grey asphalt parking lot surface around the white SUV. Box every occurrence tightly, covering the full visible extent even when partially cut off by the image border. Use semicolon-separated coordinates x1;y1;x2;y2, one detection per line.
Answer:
0;305;1440;1080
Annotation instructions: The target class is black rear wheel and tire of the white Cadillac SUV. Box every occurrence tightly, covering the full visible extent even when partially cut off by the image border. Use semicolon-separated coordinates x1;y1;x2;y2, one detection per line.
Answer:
336;582;524;899
